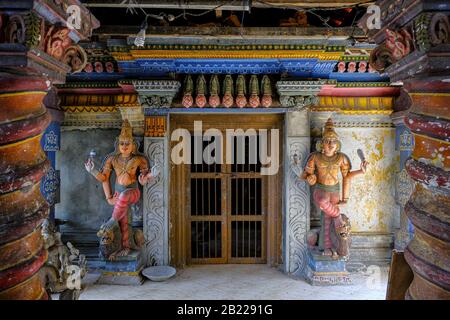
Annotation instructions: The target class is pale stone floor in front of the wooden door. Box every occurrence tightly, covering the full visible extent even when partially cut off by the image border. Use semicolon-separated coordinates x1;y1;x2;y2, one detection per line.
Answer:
80;265;388;300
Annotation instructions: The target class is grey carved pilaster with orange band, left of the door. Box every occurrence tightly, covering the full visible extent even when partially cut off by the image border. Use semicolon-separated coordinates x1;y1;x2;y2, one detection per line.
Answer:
133;80;181;266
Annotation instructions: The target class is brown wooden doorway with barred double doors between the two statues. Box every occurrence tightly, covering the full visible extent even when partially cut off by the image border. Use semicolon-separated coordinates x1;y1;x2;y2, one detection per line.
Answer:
170;115;282;265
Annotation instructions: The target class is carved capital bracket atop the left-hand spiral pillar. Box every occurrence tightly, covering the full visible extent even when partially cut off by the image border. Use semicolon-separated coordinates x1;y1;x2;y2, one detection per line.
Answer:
0;0;99;83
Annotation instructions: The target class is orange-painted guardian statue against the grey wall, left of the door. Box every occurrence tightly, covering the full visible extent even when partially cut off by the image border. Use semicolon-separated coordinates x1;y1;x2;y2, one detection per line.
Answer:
85;120;157;260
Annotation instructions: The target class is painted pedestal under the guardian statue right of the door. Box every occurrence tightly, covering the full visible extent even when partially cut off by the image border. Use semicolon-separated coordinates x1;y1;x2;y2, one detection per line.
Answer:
305;247;352;286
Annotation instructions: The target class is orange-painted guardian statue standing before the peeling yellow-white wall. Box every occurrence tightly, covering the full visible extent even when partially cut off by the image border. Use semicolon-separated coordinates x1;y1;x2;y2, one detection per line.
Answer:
301;118;368;259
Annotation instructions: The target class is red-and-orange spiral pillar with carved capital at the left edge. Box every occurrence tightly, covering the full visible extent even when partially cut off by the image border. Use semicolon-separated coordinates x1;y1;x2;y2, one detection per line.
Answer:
0;0;98;299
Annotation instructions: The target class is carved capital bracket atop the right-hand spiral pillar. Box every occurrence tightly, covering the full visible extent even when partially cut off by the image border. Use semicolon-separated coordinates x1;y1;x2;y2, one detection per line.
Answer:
360;1;450;82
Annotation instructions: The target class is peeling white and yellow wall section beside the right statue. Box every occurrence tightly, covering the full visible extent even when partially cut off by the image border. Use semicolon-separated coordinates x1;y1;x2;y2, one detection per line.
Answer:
336;128;399;233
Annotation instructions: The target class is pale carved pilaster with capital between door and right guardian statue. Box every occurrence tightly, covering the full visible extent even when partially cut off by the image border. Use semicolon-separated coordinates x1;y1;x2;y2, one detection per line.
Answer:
276;81;326;277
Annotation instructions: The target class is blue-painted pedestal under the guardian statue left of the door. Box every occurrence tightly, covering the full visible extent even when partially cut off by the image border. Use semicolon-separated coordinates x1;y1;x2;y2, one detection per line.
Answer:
89;251;144;285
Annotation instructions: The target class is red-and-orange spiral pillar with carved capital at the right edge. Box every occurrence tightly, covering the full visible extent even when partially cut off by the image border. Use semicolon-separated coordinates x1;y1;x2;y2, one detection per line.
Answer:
362;0;450;300
